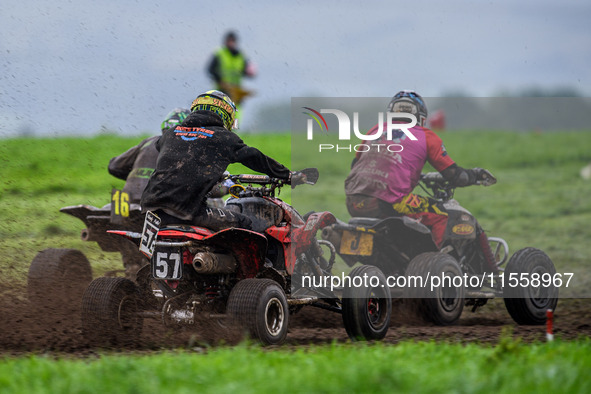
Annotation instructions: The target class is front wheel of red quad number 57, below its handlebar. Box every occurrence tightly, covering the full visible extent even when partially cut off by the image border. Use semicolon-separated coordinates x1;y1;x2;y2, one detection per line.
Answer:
342;265;392;341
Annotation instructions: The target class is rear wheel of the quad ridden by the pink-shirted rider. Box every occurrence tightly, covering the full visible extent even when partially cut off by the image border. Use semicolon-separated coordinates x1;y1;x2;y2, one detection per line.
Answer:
404;252;465;326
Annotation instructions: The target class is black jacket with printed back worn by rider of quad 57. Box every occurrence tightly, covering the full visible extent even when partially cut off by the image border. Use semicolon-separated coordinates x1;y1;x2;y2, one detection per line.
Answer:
141;111;290;220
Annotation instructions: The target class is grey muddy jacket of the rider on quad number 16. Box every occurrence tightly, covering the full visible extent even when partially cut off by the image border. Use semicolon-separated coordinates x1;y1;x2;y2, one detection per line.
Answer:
109;136;159;204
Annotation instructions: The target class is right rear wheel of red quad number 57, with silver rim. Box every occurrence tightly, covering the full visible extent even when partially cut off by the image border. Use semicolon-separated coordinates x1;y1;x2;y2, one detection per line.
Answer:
227;278;289;345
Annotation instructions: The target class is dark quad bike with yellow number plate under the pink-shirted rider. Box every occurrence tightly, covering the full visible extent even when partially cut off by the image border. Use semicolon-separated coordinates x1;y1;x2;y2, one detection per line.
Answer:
322;172;558;325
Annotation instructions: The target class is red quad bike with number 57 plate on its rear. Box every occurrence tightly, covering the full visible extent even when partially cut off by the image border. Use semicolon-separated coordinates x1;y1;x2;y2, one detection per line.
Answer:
82;169;391;345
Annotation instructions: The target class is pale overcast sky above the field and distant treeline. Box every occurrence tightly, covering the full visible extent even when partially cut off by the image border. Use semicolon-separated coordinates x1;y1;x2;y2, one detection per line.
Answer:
0;0;591;136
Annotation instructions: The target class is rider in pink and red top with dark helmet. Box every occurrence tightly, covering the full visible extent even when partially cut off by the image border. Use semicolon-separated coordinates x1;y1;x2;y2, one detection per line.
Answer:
345;90;490;247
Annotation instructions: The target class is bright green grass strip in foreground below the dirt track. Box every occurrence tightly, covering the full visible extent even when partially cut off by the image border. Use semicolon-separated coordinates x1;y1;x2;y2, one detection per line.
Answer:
0;339;591;394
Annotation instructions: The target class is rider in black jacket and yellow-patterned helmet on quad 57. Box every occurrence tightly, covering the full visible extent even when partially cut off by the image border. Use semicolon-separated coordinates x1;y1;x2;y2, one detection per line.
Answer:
141;90;291;231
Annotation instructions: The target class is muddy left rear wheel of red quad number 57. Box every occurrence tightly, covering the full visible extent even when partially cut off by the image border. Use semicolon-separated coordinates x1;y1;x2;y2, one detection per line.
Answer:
82;277;143;345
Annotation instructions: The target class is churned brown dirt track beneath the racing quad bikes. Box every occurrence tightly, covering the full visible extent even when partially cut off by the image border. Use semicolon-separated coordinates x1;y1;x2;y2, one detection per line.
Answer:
0;292;591;357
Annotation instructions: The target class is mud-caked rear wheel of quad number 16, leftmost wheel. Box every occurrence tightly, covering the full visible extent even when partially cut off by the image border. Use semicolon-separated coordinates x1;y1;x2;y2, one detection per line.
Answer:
27;249;92;319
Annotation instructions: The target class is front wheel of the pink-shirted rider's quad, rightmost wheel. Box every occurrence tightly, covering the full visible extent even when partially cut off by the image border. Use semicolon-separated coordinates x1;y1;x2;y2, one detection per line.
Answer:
503;248;558;325
